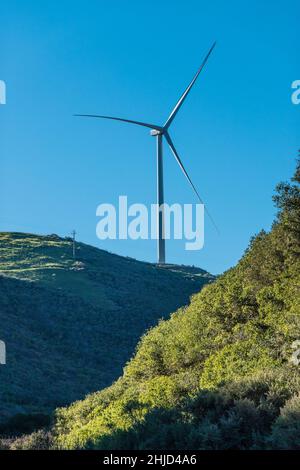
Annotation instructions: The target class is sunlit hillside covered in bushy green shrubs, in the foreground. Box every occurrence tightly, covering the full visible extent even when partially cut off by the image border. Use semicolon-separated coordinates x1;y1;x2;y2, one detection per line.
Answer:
12;156;300;449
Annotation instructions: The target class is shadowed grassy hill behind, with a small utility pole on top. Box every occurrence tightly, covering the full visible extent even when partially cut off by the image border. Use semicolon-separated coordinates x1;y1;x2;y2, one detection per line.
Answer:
0;233;213;431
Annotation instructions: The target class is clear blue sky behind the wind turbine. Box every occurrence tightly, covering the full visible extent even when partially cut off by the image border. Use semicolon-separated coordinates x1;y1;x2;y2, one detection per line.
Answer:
0;0;300;273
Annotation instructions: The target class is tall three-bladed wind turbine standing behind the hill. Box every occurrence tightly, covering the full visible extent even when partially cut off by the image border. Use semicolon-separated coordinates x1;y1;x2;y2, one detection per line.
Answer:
74;42;216;264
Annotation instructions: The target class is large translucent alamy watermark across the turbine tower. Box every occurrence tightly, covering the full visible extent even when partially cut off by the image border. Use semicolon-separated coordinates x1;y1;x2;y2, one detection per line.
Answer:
96;196;204;250
